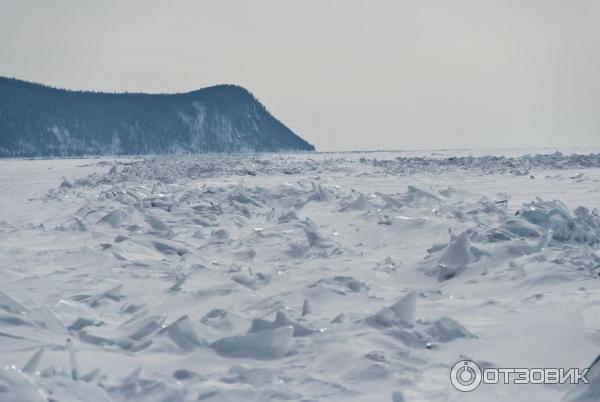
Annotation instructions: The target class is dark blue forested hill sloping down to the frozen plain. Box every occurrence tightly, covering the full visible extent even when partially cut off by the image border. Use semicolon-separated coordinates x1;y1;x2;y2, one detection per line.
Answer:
0;77;314;157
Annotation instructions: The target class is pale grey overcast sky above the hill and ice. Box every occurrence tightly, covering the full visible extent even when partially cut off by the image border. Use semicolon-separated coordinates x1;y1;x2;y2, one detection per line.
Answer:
0;0;600;151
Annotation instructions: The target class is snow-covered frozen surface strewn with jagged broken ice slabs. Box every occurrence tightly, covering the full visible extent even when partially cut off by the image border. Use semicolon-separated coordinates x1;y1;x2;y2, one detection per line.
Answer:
0;150;600;401
